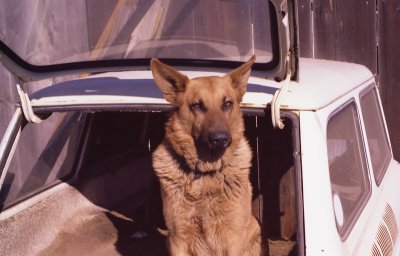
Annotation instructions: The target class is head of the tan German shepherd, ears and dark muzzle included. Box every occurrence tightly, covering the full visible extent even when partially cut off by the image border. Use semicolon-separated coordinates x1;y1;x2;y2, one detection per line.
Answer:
151;55;255;160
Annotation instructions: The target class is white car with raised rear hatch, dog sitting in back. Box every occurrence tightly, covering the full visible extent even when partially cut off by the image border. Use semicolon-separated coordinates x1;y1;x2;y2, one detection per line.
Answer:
0;0;400;256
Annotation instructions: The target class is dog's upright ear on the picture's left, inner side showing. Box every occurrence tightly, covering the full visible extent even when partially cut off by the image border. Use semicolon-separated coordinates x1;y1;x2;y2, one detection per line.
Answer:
150;59;189;105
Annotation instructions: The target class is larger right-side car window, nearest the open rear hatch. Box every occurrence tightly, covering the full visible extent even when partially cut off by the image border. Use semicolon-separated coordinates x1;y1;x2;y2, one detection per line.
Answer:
327;101;371;239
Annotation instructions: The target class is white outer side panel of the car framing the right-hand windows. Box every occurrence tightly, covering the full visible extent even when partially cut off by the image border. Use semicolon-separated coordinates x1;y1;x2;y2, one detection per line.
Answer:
299;80;400;255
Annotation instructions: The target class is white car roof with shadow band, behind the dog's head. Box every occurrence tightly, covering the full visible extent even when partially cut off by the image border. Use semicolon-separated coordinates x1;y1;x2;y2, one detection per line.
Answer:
30;59;374;111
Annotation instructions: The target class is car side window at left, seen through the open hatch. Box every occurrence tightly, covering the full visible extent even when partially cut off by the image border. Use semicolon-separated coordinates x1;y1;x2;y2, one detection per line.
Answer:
0;113;85;210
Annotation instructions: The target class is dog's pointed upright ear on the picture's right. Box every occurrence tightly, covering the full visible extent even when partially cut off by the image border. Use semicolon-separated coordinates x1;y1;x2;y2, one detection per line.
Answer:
225;55;256;102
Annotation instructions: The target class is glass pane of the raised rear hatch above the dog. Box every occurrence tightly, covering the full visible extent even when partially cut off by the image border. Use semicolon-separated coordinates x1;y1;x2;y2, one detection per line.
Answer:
0;0;277;66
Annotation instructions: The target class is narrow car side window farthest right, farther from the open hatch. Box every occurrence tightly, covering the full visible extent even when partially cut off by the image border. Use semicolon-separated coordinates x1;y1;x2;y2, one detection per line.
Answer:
361;88;391;186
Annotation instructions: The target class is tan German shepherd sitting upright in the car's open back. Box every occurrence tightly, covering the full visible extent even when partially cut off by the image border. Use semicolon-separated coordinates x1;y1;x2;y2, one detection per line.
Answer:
151;56;261;256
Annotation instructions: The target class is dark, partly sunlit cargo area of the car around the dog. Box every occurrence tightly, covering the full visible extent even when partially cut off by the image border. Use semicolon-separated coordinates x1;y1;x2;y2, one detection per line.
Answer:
0;110;303;255
